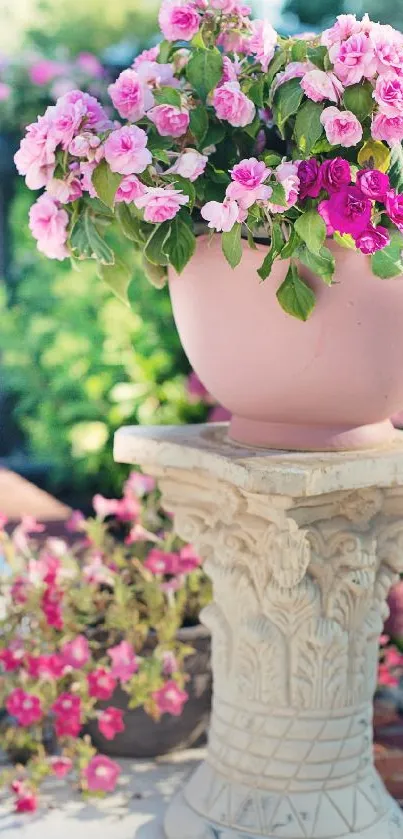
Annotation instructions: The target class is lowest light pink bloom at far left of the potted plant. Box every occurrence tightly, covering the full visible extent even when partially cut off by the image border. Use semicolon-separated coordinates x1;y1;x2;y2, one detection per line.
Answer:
29;194;69;260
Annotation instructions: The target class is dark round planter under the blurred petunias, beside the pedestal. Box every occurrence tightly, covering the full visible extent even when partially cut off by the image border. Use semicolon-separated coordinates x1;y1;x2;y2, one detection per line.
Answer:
87;626;212;758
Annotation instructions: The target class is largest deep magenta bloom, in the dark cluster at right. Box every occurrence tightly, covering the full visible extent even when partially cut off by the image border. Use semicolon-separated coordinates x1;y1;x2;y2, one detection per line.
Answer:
326;186;372;238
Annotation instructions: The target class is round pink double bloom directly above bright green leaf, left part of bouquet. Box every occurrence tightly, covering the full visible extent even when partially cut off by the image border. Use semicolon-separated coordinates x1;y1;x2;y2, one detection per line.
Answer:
105;125;152;175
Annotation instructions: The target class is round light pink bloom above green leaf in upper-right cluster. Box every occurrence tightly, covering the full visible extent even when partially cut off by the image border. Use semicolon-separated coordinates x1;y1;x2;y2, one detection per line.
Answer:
329;33;377;87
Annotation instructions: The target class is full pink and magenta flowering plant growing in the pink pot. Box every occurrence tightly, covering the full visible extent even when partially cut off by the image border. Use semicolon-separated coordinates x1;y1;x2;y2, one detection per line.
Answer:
16;5;403;320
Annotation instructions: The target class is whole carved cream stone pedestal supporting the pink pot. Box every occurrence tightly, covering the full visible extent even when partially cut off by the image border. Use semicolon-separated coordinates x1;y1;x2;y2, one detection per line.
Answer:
115;425;403;839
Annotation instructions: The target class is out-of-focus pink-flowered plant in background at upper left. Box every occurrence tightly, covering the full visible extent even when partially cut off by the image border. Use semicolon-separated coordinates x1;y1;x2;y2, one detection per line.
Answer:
0;51;110;134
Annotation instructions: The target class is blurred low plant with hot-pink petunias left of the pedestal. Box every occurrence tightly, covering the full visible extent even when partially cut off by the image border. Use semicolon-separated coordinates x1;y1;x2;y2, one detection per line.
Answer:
0;473;211;811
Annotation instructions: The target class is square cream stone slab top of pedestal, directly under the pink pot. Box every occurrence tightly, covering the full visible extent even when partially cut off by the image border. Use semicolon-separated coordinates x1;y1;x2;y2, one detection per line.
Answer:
114;423;403;498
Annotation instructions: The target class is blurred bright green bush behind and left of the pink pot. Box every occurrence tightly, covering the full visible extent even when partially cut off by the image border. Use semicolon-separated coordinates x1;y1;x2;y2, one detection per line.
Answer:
0;185;206;506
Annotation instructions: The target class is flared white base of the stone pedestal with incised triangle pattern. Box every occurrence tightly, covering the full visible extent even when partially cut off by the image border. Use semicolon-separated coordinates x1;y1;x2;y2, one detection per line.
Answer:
165;764;403;839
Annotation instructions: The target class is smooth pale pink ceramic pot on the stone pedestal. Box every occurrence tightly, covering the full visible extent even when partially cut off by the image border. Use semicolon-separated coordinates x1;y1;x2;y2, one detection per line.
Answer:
170;236;403;451
